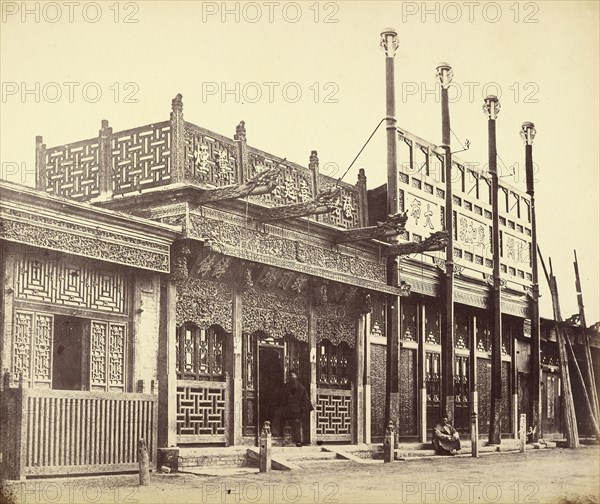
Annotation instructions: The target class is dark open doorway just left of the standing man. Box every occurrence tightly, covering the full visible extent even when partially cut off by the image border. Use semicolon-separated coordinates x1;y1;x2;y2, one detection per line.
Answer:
258;345;284;437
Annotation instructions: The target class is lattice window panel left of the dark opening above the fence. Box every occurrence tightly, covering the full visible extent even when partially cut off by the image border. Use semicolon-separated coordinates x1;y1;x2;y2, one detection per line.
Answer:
12;311;54;385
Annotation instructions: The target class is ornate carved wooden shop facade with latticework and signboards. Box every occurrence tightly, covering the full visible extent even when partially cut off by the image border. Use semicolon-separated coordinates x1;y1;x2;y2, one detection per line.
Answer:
0;95;596;475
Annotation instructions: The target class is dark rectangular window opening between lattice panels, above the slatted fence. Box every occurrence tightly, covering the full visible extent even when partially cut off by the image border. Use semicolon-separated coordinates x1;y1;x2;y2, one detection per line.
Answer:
52;315;85;390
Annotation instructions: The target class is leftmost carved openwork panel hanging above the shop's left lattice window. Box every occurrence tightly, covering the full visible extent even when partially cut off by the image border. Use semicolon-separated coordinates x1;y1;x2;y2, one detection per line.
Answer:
176;277;233;332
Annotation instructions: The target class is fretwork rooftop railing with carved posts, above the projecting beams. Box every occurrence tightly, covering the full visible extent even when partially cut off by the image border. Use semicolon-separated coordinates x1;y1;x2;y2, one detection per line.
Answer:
36;95;367;228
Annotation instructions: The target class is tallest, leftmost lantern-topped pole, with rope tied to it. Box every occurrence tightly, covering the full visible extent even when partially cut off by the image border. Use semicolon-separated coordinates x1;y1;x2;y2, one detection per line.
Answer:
381;28;400;438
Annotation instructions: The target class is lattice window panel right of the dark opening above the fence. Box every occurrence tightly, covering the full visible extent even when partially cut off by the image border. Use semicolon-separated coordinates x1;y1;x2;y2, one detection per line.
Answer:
90;320;127;390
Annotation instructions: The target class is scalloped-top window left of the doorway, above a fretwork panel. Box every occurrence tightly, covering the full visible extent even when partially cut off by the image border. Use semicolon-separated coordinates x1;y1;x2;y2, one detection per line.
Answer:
176;322;225;381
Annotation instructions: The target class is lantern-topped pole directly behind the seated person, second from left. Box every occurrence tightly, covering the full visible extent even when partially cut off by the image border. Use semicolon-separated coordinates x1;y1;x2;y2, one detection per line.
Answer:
437;63;454;421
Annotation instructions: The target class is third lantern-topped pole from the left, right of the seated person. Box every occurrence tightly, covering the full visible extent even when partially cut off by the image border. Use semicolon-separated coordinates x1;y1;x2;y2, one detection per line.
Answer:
483;95;502;444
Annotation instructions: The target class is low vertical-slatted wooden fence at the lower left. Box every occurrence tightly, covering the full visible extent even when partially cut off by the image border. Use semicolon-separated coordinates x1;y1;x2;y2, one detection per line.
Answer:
0;387;158;479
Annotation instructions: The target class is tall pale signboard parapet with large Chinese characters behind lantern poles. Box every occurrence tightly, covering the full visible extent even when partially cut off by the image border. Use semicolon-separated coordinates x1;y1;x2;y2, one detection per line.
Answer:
398;130;532;286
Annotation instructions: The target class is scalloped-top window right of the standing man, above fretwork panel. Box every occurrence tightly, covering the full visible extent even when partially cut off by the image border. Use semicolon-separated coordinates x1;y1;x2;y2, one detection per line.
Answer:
317;339;353;389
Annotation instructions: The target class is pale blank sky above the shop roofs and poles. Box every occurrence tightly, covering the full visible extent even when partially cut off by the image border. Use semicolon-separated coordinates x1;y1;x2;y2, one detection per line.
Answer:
0;0;600;324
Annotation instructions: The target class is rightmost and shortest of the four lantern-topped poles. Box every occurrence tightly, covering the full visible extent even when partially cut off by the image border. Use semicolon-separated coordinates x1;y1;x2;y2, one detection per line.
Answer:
520;122;542;443
